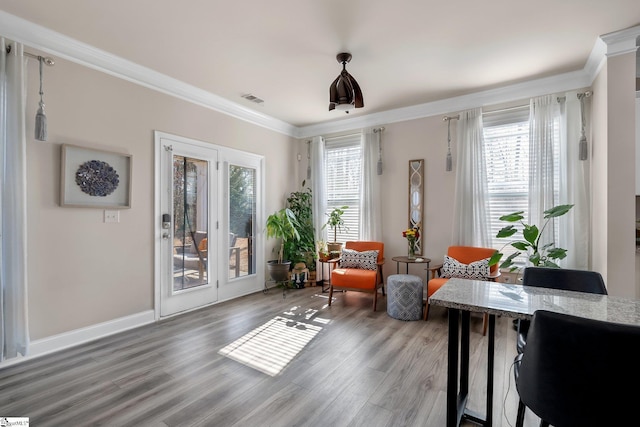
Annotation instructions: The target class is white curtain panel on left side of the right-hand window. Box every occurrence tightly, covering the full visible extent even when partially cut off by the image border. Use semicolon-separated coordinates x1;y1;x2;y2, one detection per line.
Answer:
453;108;490;247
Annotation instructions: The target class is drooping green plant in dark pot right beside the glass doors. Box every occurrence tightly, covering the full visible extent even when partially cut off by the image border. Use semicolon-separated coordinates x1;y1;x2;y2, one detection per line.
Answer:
266;208;300;282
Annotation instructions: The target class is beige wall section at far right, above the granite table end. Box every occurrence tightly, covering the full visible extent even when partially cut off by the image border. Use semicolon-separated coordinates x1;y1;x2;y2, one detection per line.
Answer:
591;53;639;297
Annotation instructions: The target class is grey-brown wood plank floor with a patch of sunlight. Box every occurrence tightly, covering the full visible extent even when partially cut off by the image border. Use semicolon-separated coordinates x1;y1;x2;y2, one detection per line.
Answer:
0;287;537;427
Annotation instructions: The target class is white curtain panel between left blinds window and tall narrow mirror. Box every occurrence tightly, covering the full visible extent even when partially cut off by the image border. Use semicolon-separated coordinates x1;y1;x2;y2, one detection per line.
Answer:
360;129;382;241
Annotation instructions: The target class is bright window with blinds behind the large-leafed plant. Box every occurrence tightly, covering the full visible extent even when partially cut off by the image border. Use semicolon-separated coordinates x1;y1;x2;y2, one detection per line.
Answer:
483;106;560;264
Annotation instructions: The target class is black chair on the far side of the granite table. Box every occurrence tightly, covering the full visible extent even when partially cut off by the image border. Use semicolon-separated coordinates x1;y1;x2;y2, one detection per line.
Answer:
513;267;607;420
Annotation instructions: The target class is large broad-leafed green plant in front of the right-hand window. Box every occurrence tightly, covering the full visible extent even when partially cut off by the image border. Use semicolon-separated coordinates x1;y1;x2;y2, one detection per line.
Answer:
489;205;573;271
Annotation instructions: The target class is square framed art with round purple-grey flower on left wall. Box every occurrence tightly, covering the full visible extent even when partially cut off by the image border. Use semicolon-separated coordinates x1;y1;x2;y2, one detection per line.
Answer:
60;144;132;209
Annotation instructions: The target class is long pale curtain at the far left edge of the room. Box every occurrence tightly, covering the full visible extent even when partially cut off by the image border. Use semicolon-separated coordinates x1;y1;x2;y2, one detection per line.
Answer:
0;38;29;360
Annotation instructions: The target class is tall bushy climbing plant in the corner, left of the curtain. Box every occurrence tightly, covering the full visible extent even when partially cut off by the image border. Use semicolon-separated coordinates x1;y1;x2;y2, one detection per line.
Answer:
284;181;316;272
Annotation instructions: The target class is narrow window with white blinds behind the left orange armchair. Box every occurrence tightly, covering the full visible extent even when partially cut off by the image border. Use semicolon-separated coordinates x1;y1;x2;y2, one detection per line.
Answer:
325;134;362;242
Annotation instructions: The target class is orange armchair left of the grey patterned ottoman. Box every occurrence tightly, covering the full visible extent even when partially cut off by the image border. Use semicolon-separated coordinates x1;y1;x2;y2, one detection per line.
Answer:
329;242;384;311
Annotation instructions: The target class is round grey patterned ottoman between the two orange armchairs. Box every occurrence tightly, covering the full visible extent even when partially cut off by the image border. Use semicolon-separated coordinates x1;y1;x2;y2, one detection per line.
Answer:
387;274;423;320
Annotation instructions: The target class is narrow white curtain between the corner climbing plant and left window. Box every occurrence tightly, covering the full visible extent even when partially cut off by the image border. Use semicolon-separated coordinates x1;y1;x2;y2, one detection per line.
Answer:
310;136;327;242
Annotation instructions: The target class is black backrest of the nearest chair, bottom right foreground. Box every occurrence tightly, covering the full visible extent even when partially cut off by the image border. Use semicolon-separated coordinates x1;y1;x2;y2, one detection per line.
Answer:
516;311;640;427
